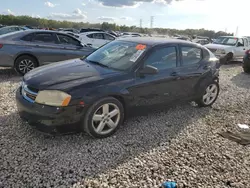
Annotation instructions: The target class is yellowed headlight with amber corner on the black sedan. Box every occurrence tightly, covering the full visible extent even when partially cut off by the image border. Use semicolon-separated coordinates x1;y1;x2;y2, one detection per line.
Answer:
35;90;71;106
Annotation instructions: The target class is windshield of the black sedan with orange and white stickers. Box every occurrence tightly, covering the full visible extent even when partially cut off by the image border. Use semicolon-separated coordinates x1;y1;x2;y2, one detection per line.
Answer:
86;41;146;71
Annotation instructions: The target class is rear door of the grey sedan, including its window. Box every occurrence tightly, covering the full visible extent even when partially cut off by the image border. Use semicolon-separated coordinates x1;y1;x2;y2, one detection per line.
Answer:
31;32;67;64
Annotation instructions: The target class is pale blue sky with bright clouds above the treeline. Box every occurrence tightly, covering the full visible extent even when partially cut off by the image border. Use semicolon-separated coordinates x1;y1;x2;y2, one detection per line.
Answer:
0;0;250;36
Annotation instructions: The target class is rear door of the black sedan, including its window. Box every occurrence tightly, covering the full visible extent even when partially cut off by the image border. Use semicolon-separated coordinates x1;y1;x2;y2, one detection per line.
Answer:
176;45;206;99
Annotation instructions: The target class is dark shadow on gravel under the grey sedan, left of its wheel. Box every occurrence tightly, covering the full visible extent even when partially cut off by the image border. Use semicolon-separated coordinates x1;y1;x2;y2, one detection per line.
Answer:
0;68;22;83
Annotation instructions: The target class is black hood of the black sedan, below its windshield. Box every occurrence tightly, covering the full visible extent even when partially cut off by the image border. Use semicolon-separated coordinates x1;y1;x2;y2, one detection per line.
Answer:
24;59;121;90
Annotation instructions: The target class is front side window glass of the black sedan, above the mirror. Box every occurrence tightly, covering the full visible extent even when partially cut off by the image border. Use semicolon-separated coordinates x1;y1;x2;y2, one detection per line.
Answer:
145;47;177;70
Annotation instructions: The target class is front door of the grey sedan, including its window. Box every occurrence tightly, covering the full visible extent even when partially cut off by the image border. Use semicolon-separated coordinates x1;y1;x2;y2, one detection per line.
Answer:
56;33;93;59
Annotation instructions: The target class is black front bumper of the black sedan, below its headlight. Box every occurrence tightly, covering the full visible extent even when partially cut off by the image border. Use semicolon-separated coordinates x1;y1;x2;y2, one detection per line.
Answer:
16;88;85;127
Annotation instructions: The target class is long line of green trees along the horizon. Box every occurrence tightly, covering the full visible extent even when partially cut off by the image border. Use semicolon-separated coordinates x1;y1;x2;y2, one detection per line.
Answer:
0;15;233;38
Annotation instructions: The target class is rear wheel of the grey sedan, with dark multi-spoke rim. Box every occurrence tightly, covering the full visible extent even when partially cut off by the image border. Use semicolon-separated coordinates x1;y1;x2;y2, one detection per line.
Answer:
14;55;38;76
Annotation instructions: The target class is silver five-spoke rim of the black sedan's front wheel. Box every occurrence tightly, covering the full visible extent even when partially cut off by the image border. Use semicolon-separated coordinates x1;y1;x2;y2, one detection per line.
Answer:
92;103;120;135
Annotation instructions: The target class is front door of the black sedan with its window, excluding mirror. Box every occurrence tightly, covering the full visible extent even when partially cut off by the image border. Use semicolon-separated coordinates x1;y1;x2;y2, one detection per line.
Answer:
128;45;179;106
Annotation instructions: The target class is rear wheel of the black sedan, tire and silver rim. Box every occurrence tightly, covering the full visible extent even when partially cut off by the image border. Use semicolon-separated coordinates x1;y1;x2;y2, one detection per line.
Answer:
195;80;220;107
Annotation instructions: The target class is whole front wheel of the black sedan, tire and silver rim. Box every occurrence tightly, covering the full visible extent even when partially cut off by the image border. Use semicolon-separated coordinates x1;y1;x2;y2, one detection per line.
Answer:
81;97;124;138
